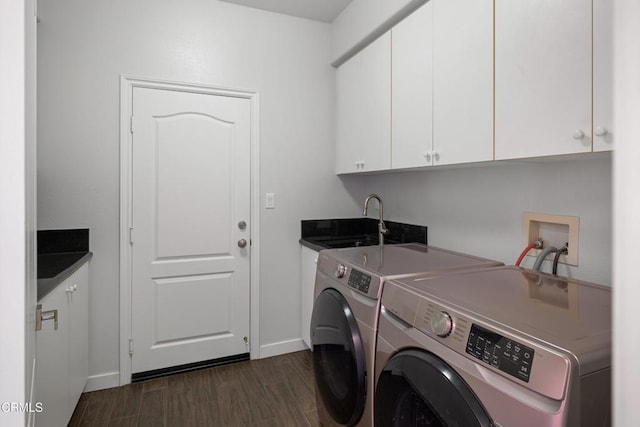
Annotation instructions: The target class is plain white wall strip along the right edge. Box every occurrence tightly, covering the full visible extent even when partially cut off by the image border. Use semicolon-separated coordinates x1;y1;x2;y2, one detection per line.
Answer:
613;0;640;426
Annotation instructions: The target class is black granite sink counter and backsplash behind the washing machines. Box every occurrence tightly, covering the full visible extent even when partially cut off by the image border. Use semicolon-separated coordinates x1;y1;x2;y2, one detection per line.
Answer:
300;218;427;251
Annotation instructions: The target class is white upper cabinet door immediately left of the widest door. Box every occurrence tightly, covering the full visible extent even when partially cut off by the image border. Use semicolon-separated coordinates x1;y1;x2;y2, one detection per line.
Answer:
433;0;492;165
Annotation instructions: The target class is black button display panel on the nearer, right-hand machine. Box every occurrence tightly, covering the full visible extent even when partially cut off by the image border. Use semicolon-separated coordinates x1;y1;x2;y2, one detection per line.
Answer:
466;323;534;383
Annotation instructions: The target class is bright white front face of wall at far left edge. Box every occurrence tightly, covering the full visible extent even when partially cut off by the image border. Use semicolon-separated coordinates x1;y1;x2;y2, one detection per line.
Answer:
0;0;26;426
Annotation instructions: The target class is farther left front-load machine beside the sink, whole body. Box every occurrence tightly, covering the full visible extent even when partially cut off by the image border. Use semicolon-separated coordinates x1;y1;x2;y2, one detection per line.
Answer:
311;244;502;426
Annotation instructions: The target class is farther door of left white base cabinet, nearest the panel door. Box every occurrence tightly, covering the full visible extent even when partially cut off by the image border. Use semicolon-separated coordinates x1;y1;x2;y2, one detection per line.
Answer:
67;264;89;414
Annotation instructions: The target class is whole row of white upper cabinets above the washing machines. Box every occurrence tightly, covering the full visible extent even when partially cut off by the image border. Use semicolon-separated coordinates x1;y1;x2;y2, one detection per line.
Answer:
337;0;615;173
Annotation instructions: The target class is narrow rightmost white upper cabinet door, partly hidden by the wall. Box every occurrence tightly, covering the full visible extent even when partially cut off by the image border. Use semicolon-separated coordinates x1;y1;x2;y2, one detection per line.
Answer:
593;0;614;151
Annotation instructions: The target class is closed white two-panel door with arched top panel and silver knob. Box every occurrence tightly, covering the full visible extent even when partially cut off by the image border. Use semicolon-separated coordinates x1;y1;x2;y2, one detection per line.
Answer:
132;88;251;373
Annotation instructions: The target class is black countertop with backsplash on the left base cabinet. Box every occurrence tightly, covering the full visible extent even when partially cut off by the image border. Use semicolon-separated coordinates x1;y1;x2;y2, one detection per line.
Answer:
38;229;93;301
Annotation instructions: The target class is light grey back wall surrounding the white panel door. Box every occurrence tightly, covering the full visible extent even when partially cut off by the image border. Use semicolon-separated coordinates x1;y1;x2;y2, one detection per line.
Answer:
38;0;359;388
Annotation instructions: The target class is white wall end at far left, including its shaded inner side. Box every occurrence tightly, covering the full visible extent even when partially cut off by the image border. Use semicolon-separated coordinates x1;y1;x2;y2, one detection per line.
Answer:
0;0;36;426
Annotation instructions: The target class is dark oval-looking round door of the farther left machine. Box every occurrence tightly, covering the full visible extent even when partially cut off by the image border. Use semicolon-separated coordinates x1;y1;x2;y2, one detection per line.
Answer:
311;288;366;426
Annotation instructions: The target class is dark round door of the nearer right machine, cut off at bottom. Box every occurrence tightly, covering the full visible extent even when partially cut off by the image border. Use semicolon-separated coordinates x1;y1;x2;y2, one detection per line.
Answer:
375;350;493;427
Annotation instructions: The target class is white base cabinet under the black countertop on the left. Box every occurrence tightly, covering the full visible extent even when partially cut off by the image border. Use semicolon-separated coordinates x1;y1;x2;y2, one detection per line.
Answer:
35;263;89;427
